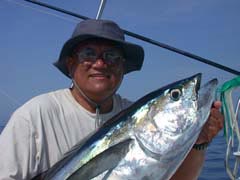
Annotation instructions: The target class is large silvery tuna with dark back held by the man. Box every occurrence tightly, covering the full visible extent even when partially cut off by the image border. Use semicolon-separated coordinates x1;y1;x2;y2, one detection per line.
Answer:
33;73;218;180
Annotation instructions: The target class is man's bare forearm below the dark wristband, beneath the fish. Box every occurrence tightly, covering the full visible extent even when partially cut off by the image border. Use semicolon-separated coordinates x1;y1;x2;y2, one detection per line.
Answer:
171;149;205;180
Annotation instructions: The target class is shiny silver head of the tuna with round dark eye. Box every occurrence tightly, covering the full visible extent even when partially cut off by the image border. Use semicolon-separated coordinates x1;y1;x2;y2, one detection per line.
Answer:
136;74;217;159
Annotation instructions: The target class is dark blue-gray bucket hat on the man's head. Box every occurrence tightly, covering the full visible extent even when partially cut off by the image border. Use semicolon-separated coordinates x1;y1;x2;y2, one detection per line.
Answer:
54;19;144;78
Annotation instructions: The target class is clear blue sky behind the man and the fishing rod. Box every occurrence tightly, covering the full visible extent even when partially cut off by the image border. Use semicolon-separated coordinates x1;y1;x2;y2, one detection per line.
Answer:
0;0;240;124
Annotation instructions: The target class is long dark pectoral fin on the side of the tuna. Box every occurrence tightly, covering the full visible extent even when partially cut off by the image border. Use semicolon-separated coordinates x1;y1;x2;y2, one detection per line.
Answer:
69;139;133;180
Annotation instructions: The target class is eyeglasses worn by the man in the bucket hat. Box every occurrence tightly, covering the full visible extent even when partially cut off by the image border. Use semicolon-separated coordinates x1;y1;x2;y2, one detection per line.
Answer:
76;48;124;66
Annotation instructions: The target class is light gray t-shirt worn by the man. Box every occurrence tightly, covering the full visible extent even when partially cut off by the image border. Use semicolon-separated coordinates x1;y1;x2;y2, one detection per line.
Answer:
0;89;131;180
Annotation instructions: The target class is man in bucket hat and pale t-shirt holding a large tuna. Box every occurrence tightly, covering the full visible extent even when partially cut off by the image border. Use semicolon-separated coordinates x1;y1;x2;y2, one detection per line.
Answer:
0;20;223;180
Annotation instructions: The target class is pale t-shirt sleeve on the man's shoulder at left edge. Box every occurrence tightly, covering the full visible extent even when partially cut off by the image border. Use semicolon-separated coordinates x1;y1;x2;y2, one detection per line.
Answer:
0;113;37;180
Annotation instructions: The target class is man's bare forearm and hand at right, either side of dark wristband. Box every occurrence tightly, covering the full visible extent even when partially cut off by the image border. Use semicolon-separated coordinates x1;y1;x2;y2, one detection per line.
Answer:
171;101;224;180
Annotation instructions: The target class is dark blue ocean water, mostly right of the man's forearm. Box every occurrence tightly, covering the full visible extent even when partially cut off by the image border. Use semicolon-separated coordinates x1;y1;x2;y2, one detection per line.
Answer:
0;121;233;180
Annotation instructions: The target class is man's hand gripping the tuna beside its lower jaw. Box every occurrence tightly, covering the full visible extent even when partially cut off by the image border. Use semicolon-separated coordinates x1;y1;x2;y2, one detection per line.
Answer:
196;101;224;144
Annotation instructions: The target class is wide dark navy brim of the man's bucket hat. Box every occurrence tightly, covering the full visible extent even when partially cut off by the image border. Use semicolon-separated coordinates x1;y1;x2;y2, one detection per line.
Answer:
54;34;144;78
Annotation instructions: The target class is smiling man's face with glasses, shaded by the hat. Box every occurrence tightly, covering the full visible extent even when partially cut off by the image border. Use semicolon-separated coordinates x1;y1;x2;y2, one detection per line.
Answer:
68;40;124;102
